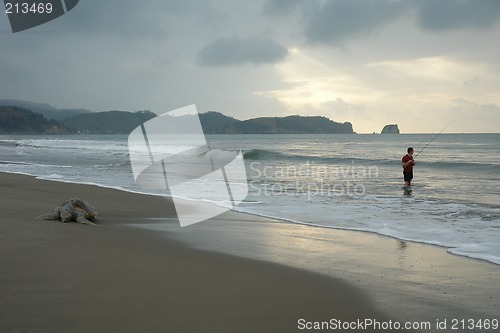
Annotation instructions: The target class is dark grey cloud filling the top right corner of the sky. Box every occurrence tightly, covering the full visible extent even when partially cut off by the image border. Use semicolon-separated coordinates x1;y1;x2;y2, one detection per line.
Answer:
417;0;500;31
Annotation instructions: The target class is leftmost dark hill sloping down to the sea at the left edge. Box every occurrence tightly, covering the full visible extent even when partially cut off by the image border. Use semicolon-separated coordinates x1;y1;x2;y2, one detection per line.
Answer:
0;106;72;134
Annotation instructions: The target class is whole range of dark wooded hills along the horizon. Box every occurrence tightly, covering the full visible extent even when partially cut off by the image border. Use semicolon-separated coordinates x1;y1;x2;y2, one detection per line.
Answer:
0;100;354;134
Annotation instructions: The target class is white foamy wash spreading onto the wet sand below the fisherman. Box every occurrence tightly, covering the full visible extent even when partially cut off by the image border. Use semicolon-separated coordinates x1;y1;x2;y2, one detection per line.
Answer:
236;192;500;265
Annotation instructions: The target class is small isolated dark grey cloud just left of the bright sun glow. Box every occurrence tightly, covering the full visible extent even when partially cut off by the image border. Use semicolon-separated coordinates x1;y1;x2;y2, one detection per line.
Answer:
198;37;288;66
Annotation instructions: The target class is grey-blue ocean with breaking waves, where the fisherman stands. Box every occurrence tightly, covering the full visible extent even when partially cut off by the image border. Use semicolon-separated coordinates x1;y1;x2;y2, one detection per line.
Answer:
0;134;500;265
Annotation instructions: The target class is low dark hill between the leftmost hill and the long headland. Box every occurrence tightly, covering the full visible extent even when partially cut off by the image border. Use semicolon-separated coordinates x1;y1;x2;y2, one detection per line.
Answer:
61;111;156;134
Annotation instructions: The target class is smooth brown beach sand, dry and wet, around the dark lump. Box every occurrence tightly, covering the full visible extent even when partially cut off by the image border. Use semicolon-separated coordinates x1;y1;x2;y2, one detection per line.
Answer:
0;173;500;332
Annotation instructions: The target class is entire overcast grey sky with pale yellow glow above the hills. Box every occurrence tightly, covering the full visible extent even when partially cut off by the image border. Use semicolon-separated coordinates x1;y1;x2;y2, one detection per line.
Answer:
0;0;500;133
